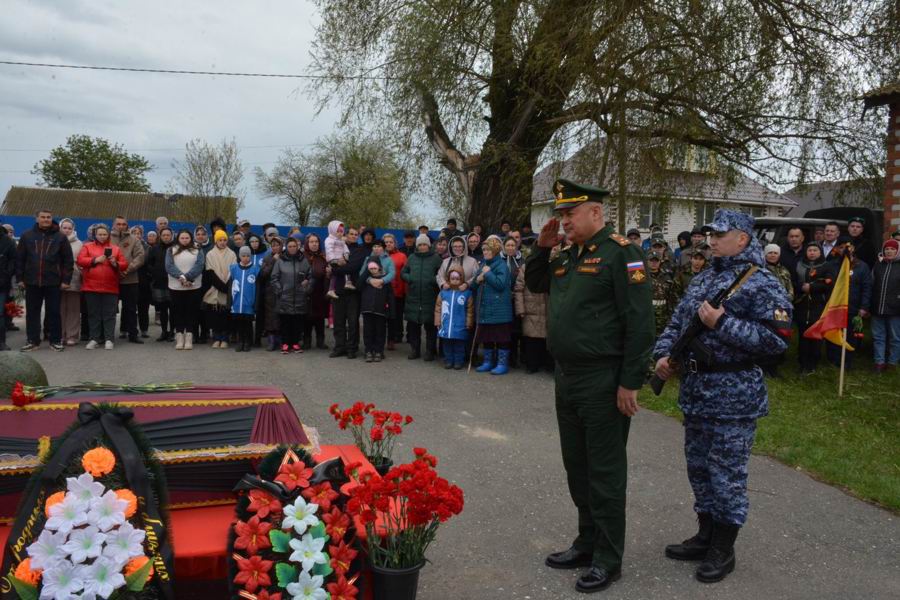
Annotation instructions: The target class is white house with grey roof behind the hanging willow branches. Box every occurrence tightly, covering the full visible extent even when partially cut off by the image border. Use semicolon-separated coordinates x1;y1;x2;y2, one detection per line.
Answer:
531;140;797;244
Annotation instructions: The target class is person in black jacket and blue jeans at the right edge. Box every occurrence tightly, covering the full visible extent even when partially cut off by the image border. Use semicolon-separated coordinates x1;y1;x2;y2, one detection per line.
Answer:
872;239;900;373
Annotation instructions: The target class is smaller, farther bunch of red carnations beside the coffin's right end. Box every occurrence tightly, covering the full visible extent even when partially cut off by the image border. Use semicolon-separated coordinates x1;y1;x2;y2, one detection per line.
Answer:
328;402;413;467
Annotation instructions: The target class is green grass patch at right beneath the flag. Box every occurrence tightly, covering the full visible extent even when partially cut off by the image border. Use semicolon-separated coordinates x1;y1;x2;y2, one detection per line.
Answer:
640;340;900;512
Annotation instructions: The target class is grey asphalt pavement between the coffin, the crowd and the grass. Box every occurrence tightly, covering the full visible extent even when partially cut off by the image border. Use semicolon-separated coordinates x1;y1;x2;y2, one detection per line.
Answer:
10;328;900;600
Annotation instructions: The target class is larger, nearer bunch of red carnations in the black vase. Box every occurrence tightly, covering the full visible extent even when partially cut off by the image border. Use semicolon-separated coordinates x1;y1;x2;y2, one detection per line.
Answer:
347;448;463;569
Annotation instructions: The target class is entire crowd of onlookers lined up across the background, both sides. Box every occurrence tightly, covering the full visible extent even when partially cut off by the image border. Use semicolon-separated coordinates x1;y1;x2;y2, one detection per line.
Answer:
0;211;900;375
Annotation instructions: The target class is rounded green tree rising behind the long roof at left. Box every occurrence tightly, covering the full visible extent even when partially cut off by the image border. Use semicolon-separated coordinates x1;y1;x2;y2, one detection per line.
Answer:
32;135;152;192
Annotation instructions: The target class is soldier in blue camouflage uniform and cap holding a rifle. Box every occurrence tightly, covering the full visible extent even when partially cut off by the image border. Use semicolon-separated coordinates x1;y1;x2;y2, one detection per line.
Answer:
653;209;792;583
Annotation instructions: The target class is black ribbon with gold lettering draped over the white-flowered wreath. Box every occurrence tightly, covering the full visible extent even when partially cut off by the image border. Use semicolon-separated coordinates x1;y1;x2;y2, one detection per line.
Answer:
0;402;175;600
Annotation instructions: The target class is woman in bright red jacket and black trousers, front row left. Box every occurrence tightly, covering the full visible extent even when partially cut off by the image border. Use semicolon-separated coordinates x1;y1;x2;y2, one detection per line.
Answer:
77;224;128;350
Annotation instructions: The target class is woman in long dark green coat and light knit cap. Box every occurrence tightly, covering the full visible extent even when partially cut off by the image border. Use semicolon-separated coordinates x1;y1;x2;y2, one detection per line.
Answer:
400;233;441;361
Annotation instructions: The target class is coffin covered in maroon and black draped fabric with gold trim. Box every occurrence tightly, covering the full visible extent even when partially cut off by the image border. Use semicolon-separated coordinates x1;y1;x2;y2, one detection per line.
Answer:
0;386;316;523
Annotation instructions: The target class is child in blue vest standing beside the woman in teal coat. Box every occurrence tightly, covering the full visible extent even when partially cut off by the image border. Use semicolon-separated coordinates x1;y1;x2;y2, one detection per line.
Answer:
434;265;475;370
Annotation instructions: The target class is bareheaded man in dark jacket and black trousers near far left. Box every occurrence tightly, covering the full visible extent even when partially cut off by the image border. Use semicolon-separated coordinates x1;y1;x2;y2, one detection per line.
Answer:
16;210;75;352
